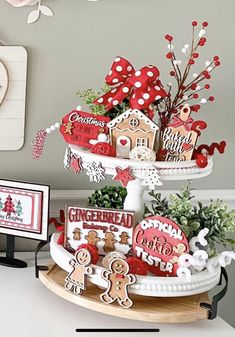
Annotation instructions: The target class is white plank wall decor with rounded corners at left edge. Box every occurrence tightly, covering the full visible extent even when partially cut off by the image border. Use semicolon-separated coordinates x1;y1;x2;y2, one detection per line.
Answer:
0;46;27;151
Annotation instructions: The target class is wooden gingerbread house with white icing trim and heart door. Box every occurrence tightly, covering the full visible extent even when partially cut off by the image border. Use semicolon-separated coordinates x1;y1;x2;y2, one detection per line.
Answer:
107;109;159;158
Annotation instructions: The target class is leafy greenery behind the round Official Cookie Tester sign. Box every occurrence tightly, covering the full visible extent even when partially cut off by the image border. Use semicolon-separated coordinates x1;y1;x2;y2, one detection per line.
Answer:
145;186;235;256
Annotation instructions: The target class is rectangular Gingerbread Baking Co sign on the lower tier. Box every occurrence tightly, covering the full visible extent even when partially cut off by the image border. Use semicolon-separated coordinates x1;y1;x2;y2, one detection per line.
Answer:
64;206;134;255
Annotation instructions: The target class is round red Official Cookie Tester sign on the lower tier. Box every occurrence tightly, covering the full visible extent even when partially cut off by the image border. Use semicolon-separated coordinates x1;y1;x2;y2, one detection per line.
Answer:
133;216;189;276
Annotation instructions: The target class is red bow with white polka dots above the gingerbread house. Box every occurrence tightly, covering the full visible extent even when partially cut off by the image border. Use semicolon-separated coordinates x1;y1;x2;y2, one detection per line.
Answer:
94;57;167;118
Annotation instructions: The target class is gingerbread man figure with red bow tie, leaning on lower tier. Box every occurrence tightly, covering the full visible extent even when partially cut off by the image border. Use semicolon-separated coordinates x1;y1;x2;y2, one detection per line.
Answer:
100;258;136;308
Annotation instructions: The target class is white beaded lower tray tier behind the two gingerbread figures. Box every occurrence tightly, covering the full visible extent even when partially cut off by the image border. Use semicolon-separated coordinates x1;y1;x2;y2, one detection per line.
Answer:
50;233;220;297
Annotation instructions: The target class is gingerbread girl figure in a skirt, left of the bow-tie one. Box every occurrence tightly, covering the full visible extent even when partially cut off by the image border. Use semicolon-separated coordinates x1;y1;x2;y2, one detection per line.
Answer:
64;248;93;295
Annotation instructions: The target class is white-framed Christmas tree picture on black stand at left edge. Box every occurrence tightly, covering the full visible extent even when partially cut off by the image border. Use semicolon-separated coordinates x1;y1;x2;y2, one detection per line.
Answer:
0;180;50;241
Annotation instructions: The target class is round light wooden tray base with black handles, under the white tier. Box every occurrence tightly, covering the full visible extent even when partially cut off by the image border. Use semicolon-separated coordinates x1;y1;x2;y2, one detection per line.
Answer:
39;264;210;323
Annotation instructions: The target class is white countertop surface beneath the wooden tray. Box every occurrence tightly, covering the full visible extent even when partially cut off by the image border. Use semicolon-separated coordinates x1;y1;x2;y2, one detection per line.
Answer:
0;252;235;337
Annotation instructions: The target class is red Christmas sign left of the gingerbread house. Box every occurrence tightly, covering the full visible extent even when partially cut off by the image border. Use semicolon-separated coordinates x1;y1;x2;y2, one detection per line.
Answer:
60;110;110;148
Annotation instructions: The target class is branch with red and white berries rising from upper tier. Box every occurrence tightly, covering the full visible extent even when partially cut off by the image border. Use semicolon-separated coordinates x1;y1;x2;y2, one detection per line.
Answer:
155;21;220;128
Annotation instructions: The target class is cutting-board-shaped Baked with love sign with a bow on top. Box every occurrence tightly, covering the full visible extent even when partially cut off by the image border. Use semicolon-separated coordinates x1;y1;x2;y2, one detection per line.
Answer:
157;104;198;161
